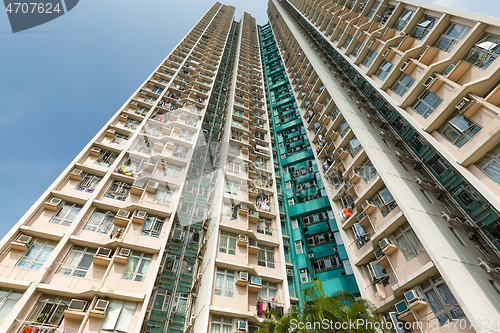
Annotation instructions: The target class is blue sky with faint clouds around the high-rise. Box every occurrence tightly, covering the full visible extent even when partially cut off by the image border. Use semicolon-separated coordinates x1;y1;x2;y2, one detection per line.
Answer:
0;0;500;237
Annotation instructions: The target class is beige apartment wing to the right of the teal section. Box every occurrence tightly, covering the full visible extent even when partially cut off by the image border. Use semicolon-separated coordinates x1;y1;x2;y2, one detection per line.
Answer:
268;0;500;332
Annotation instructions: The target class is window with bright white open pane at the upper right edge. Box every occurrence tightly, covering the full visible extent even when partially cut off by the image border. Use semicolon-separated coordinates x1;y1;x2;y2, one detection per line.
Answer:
465;33;500;69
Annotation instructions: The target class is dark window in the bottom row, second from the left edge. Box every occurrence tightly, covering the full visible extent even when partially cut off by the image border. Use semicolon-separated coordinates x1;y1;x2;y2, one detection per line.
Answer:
21;295;71;331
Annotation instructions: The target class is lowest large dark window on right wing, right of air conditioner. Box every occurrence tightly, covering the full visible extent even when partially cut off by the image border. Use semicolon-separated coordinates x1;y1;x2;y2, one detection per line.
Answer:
420;274;465;325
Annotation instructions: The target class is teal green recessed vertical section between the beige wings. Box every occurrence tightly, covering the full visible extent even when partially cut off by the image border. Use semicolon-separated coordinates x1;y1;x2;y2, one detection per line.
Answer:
260;25;359;305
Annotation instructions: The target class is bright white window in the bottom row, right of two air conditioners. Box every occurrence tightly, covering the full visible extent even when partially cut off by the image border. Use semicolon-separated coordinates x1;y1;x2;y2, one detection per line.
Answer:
99;300;137;333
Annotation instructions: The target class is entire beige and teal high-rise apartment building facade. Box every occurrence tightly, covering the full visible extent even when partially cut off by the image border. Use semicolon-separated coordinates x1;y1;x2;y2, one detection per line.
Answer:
0;0;500;333
